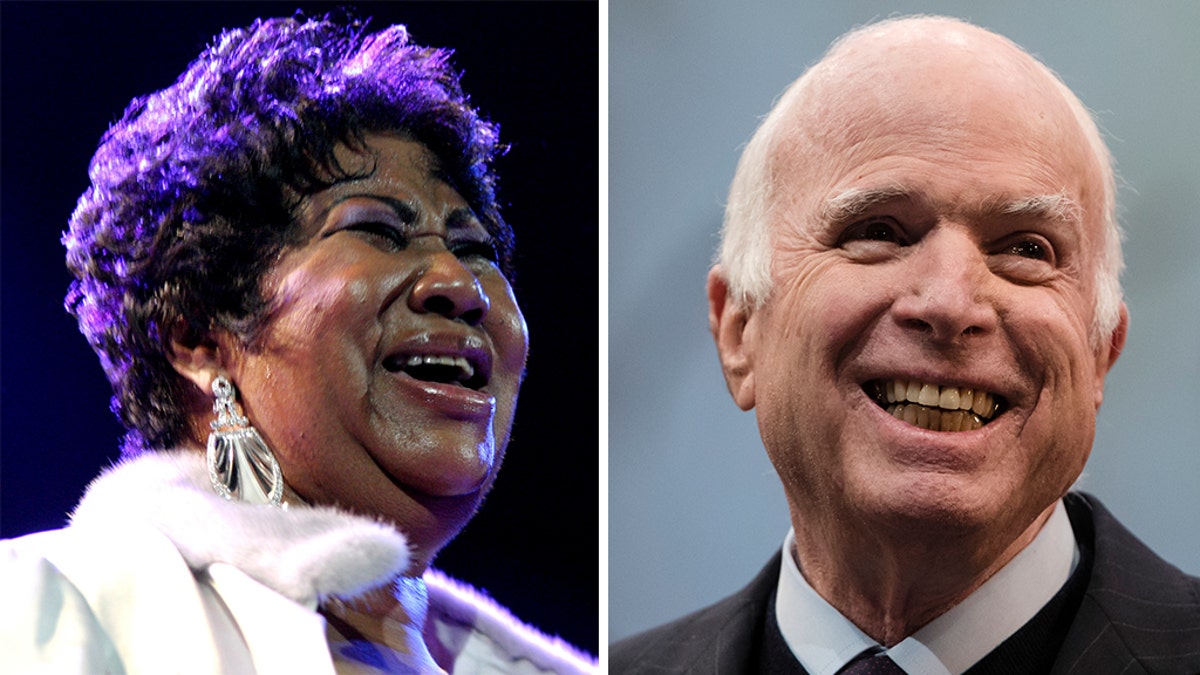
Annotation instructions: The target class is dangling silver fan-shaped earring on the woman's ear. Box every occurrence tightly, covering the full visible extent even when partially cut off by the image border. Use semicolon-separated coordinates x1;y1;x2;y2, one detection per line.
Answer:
209;376;283;507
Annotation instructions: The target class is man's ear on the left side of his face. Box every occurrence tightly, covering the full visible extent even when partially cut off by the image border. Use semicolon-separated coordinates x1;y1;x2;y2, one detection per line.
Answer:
708;265;755;410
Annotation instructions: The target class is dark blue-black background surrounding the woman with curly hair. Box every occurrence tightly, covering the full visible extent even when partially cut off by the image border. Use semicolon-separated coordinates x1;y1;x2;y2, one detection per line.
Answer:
0;1;599;653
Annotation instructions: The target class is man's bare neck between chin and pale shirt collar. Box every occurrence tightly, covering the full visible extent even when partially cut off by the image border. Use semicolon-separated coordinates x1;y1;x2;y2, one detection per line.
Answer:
792;504;1054;646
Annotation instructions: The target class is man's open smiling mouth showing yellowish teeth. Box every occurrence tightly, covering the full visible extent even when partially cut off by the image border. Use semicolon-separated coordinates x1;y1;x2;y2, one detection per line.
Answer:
864;380;1004;431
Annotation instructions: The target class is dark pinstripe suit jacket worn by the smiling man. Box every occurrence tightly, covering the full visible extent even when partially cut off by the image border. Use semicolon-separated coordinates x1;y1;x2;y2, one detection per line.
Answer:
610;494;1200;675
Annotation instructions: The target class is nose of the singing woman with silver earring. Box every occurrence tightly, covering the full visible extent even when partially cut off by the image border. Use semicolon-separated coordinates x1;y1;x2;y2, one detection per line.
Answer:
408;249;491;325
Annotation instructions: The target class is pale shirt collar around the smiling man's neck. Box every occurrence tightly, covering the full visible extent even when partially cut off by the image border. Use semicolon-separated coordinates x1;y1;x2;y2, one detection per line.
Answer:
775;500;1079;675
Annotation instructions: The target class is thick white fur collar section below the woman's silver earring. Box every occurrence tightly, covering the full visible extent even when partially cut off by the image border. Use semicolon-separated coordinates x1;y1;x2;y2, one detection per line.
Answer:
71;450;409;608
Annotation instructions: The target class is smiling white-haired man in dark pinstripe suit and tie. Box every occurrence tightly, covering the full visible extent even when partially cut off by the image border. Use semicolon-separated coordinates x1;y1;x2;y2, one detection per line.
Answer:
611;17;1200;675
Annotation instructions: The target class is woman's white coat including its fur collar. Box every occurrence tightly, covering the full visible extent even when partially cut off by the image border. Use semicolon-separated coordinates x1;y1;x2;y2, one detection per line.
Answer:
0;452;595;673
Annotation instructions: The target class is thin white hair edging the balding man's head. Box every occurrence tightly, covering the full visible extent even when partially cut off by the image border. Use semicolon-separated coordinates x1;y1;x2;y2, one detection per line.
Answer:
716;16;1124;346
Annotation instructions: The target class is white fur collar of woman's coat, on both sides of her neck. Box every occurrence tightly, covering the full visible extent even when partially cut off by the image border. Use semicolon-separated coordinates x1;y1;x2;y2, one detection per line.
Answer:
71;450;596;673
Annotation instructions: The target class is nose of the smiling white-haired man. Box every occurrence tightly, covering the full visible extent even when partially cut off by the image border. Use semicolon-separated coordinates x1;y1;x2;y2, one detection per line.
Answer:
892;228;998;344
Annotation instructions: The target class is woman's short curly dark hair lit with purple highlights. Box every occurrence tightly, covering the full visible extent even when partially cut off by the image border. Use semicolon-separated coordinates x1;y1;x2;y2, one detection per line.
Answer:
62;18;512;454
